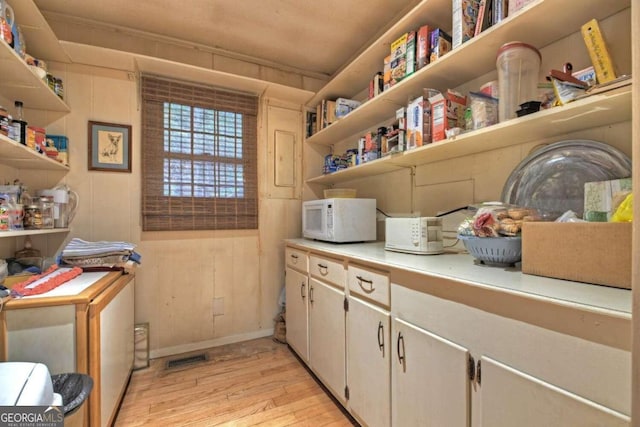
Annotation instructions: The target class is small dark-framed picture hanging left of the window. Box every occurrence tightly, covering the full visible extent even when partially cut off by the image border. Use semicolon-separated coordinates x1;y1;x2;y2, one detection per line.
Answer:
89;121;131;172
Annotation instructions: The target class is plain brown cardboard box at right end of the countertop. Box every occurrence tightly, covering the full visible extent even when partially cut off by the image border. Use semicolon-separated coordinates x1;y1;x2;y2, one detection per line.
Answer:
522;222;631;289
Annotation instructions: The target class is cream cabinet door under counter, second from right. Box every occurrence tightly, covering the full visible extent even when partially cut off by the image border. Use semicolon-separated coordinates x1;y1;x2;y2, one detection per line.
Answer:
391;318;470;427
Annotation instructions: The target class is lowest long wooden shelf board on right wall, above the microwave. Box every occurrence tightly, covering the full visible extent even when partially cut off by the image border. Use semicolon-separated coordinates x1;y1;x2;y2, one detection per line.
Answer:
306;85;631;184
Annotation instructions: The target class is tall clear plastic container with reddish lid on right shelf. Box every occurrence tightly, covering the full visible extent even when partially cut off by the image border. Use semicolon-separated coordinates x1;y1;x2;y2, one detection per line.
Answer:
496;42;542;122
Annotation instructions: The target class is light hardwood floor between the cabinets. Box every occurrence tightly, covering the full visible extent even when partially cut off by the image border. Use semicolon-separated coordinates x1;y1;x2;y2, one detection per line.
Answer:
115;338;357;427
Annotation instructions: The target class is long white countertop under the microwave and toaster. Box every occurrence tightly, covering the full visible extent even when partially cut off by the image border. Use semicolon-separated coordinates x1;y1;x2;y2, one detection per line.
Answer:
285;239;632;318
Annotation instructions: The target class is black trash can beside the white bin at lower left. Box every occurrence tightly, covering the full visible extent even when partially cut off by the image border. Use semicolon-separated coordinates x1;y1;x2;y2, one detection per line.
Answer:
51;373;93;427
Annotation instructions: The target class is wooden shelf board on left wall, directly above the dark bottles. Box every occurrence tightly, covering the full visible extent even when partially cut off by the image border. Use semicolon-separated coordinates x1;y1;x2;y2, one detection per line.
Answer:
0;41;71;113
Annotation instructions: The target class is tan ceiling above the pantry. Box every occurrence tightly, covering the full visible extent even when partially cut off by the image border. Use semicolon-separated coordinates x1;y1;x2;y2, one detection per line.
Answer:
35;0;417;76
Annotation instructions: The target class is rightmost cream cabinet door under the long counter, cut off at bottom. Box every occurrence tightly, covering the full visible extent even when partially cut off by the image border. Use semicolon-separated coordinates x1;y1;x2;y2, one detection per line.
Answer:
480;356;630;427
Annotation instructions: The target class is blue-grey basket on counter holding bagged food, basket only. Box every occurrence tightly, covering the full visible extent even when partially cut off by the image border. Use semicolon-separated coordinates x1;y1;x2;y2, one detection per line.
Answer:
458;236;522;267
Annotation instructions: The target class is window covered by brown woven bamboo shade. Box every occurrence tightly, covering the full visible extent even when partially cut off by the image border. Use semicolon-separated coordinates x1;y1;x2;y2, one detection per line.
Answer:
141;76;258;231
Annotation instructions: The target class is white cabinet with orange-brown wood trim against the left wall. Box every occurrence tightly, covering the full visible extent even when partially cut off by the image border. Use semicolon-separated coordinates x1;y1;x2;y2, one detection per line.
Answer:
0;272;134;426
